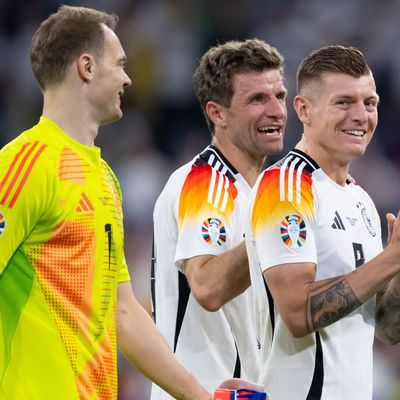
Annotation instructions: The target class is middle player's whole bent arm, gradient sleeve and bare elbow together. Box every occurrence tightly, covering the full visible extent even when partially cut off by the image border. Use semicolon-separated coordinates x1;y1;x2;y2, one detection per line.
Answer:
170;153;250;311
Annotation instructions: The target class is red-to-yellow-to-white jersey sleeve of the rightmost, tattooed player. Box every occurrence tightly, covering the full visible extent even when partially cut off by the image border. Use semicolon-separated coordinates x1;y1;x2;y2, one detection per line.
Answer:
251;167;317;271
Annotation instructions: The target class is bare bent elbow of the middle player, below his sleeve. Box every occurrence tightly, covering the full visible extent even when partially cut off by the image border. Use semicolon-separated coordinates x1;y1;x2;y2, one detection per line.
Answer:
182;241;250;311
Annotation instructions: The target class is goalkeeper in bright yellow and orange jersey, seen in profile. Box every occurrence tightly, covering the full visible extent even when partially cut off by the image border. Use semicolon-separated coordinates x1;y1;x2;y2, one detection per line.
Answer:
0;6;211;400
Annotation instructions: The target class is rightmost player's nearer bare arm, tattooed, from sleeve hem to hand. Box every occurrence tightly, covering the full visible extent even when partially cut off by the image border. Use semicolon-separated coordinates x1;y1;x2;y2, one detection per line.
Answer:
264;209;400;337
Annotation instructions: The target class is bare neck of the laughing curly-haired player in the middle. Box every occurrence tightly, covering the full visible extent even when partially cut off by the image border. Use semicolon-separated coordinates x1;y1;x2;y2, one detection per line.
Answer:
211;136;265;187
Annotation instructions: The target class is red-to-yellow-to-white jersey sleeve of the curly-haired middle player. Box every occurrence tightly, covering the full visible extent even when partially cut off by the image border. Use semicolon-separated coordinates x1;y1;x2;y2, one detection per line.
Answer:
175;164;237;266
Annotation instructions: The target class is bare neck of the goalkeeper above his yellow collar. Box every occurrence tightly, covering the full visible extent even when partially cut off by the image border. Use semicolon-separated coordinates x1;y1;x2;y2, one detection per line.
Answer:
43;90;99;147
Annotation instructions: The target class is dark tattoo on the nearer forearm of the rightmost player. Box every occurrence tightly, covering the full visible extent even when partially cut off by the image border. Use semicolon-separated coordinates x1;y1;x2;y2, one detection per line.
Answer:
306;278;361;332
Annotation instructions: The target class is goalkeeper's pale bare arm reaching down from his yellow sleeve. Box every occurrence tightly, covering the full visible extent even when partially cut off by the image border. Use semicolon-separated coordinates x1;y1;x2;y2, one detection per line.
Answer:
117;282;211;400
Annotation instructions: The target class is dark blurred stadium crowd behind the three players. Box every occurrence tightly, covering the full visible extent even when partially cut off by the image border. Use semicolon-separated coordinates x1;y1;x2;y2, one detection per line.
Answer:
0;0;400;400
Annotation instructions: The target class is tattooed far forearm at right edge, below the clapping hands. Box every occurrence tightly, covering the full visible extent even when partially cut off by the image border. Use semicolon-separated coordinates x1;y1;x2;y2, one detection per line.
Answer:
375;288;400;344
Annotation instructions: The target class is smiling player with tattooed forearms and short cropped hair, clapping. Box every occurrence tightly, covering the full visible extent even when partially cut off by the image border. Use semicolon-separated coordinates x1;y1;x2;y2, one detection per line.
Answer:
246;46;400;400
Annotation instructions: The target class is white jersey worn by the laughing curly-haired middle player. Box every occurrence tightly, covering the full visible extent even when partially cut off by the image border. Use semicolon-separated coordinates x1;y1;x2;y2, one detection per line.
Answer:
151;146;259;400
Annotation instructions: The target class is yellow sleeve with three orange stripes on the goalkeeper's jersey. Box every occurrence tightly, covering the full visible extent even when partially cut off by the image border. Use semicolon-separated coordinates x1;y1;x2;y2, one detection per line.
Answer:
0;142;53;274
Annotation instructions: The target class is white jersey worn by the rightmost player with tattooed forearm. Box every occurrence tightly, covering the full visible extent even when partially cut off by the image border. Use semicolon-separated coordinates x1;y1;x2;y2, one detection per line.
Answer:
246;150;382;400
